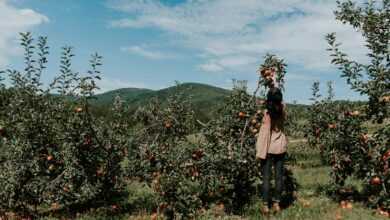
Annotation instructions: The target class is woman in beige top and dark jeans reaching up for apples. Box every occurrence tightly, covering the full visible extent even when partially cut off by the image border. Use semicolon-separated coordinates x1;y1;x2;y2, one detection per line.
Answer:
256;87;288;214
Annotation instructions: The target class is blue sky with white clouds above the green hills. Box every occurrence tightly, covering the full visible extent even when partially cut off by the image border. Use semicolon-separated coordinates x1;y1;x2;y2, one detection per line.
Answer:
0;0;367;103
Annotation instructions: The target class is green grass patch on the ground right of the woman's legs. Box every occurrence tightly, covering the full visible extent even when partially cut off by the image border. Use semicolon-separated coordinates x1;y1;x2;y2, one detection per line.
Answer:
238;139;387;220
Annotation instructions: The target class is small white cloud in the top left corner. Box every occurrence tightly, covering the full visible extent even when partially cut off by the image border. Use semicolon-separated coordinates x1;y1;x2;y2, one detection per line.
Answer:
0;0;49;67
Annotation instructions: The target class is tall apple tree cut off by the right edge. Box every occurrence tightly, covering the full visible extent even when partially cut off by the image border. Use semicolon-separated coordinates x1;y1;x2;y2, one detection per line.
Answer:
327;0;390;211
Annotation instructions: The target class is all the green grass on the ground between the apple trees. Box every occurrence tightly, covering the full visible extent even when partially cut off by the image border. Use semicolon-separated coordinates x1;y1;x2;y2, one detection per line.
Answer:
39;139;388;220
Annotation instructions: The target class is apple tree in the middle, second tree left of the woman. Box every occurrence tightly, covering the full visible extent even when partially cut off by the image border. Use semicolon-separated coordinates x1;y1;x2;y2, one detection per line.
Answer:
128;84;201;217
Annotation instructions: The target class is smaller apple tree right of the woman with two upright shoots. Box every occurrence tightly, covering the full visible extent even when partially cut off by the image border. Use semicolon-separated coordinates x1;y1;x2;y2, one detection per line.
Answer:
307;82;365;179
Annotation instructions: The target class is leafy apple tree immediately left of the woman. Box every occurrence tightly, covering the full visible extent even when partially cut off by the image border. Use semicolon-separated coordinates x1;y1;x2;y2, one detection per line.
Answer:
198;81;262;210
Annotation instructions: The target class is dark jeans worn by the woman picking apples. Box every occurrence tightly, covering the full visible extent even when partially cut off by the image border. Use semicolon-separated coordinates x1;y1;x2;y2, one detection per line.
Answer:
261;154;285;203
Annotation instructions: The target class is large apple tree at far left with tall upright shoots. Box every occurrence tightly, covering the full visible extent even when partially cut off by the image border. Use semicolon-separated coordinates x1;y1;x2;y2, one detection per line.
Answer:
0;33;127;217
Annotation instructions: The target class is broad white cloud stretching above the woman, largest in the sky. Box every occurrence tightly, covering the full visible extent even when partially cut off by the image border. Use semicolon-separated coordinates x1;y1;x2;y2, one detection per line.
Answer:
110;0;366;72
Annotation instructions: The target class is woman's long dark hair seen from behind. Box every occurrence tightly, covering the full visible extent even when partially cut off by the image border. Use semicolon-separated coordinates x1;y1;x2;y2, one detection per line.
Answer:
266;87;283;118
